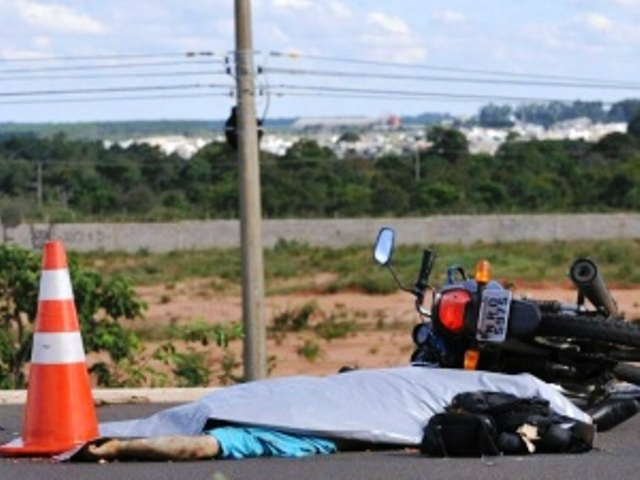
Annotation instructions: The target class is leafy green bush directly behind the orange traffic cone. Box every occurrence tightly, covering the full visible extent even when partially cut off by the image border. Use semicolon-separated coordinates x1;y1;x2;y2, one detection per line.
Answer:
0;245;146;388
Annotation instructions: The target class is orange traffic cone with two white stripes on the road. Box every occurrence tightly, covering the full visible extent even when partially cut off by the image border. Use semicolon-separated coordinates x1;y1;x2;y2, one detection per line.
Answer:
0;241;98;456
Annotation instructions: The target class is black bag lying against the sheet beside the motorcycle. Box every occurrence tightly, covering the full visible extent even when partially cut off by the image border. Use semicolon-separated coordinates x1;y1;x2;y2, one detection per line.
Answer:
420;391;595;457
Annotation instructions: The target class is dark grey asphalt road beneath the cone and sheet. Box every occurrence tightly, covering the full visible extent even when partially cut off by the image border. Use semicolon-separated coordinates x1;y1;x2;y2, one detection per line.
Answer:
0;404;640;480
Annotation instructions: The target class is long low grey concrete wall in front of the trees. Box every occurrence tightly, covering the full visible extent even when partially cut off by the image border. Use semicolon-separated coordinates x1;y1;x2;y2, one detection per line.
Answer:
5;214;640;252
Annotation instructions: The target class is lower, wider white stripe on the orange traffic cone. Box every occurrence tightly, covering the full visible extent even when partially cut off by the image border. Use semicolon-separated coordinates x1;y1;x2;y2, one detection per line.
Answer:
31;332;85;365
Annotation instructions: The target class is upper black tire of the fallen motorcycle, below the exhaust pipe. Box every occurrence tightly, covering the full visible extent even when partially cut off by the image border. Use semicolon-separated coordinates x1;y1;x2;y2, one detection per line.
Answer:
536;314;640;348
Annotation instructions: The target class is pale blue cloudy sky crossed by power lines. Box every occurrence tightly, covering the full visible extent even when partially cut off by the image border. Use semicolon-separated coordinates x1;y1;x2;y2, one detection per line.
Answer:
0;0;640;122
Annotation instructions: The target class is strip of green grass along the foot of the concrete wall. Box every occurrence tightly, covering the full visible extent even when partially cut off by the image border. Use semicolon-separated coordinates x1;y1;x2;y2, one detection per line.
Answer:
73;240;640;294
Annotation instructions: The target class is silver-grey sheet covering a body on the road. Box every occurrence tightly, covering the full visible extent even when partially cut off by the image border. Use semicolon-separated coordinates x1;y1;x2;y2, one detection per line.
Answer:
100;367;591;446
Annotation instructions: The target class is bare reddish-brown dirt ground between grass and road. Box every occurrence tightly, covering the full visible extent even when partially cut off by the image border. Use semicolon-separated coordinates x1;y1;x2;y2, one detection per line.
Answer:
136;279;640;385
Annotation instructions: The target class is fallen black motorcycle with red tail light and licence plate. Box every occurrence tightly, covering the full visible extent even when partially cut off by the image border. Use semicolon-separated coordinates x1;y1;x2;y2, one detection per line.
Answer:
374;228;640;412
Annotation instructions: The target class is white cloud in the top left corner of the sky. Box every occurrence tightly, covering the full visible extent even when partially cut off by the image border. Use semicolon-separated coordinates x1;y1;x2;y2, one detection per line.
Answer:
13;0;107;35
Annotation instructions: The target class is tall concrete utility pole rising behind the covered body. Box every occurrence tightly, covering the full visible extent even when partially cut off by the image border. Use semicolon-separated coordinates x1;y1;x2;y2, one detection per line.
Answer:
235;0;267;381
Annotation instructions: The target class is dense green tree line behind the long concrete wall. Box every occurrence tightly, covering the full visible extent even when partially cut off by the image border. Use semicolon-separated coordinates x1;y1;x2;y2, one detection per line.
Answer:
0;116;640;225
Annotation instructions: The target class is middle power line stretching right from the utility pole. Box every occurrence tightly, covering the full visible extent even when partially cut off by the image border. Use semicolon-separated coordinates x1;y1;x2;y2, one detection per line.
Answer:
261;67;640;90
